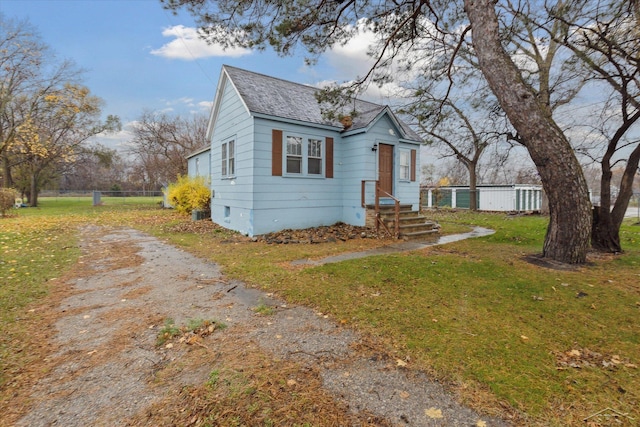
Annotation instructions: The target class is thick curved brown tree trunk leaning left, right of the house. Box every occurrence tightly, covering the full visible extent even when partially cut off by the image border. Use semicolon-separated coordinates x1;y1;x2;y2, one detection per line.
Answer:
464;0;592;264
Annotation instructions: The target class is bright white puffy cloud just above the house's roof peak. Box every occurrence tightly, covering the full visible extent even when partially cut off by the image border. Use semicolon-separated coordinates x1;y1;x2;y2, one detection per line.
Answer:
151;25;251;61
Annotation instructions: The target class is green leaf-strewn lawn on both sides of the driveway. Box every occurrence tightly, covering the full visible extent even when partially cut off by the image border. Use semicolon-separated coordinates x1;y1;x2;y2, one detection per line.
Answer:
0;198;640;426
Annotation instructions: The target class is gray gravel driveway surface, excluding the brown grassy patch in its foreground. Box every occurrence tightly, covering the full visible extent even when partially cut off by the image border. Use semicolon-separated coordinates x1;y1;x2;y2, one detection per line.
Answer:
17;226;507;427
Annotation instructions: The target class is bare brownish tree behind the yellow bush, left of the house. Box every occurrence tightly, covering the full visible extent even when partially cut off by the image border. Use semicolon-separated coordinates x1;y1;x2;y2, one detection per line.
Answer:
129;111;208;190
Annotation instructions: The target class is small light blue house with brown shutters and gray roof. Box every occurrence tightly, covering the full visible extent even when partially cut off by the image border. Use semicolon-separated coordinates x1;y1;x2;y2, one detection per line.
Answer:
189;65;428;236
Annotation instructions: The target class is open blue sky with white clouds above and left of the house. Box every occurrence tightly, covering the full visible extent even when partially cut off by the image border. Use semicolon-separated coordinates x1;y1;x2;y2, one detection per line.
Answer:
0;0;384;150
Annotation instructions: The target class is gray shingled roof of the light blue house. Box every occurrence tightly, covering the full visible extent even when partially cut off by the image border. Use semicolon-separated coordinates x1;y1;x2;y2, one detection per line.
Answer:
223;65;421;141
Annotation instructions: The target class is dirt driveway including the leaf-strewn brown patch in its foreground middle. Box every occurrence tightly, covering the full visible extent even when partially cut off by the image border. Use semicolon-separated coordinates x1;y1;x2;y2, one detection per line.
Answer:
11;226;507;427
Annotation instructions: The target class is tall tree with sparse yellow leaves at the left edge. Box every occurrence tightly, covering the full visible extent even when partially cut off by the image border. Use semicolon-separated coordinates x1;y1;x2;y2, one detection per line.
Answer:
0;15;120;206
